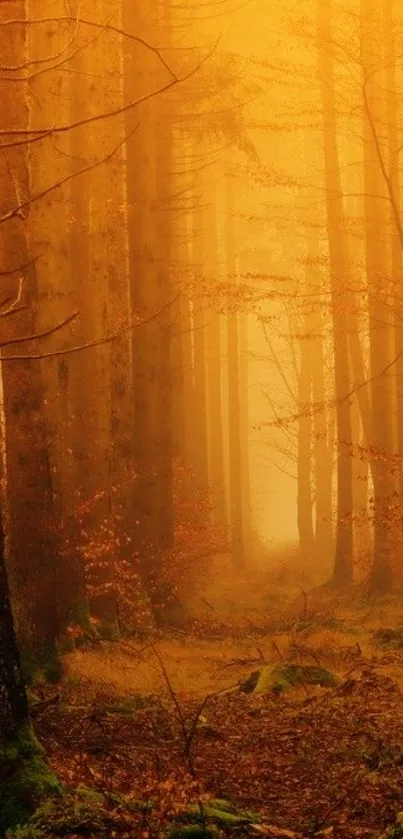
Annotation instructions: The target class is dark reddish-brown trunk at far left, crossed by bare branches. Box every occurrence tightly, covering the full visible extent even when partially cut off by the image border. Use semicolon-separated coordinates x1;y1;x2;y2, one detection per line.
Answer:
0;2;68;652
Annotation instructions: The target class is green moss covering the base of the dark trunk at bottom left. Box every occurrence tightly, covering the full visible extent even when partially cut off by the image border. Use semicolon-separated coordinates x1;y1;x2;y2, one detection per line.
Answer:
0;726;61;834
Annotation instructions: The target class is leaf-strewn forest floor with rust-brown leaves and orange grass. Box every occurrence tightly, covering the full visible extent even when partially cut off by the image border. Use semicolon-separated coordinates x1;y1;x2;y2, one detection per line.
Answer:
27;558;403;839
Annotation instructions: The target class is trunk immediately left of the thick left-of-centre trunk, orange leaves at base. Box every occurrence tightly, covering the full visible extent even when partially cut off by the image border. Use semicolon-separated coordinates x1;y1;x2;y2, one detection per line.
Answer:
91;3;134;619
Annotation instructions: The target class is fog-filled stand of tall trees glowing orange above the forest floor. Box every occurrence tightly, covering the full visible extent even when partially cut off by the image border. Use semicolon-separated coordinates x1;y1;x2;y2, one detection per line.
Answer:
0;0;403;740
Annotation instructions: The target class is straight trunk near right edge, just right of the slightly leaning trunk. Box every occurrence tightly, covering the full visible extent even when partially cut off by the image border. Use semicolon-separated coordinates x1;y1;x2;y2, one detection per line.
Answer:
361;0;393;593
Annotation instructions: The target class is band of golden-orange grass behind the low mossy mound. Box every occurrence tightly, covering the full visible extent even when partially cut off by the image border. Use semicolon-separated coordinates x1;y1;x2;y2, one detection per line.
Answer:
65;596;403;699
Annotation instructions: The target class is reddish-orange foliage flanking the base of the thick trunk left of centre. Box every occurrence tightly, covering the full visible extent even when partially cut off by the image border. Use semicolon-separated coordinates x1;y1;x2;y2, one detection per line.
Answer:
64;459;227;626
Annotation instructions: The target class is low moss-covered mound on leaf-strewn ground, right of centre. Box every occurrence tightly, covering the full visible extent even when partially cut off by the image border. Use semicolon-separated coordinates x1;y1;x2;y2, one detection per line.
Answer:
239;664;341;693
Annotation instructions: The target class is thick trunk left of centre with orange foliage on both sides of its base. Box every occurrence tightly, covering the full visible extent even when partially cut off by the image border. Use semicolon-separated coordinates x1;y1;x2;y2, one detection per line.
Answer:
123;0;174;622
